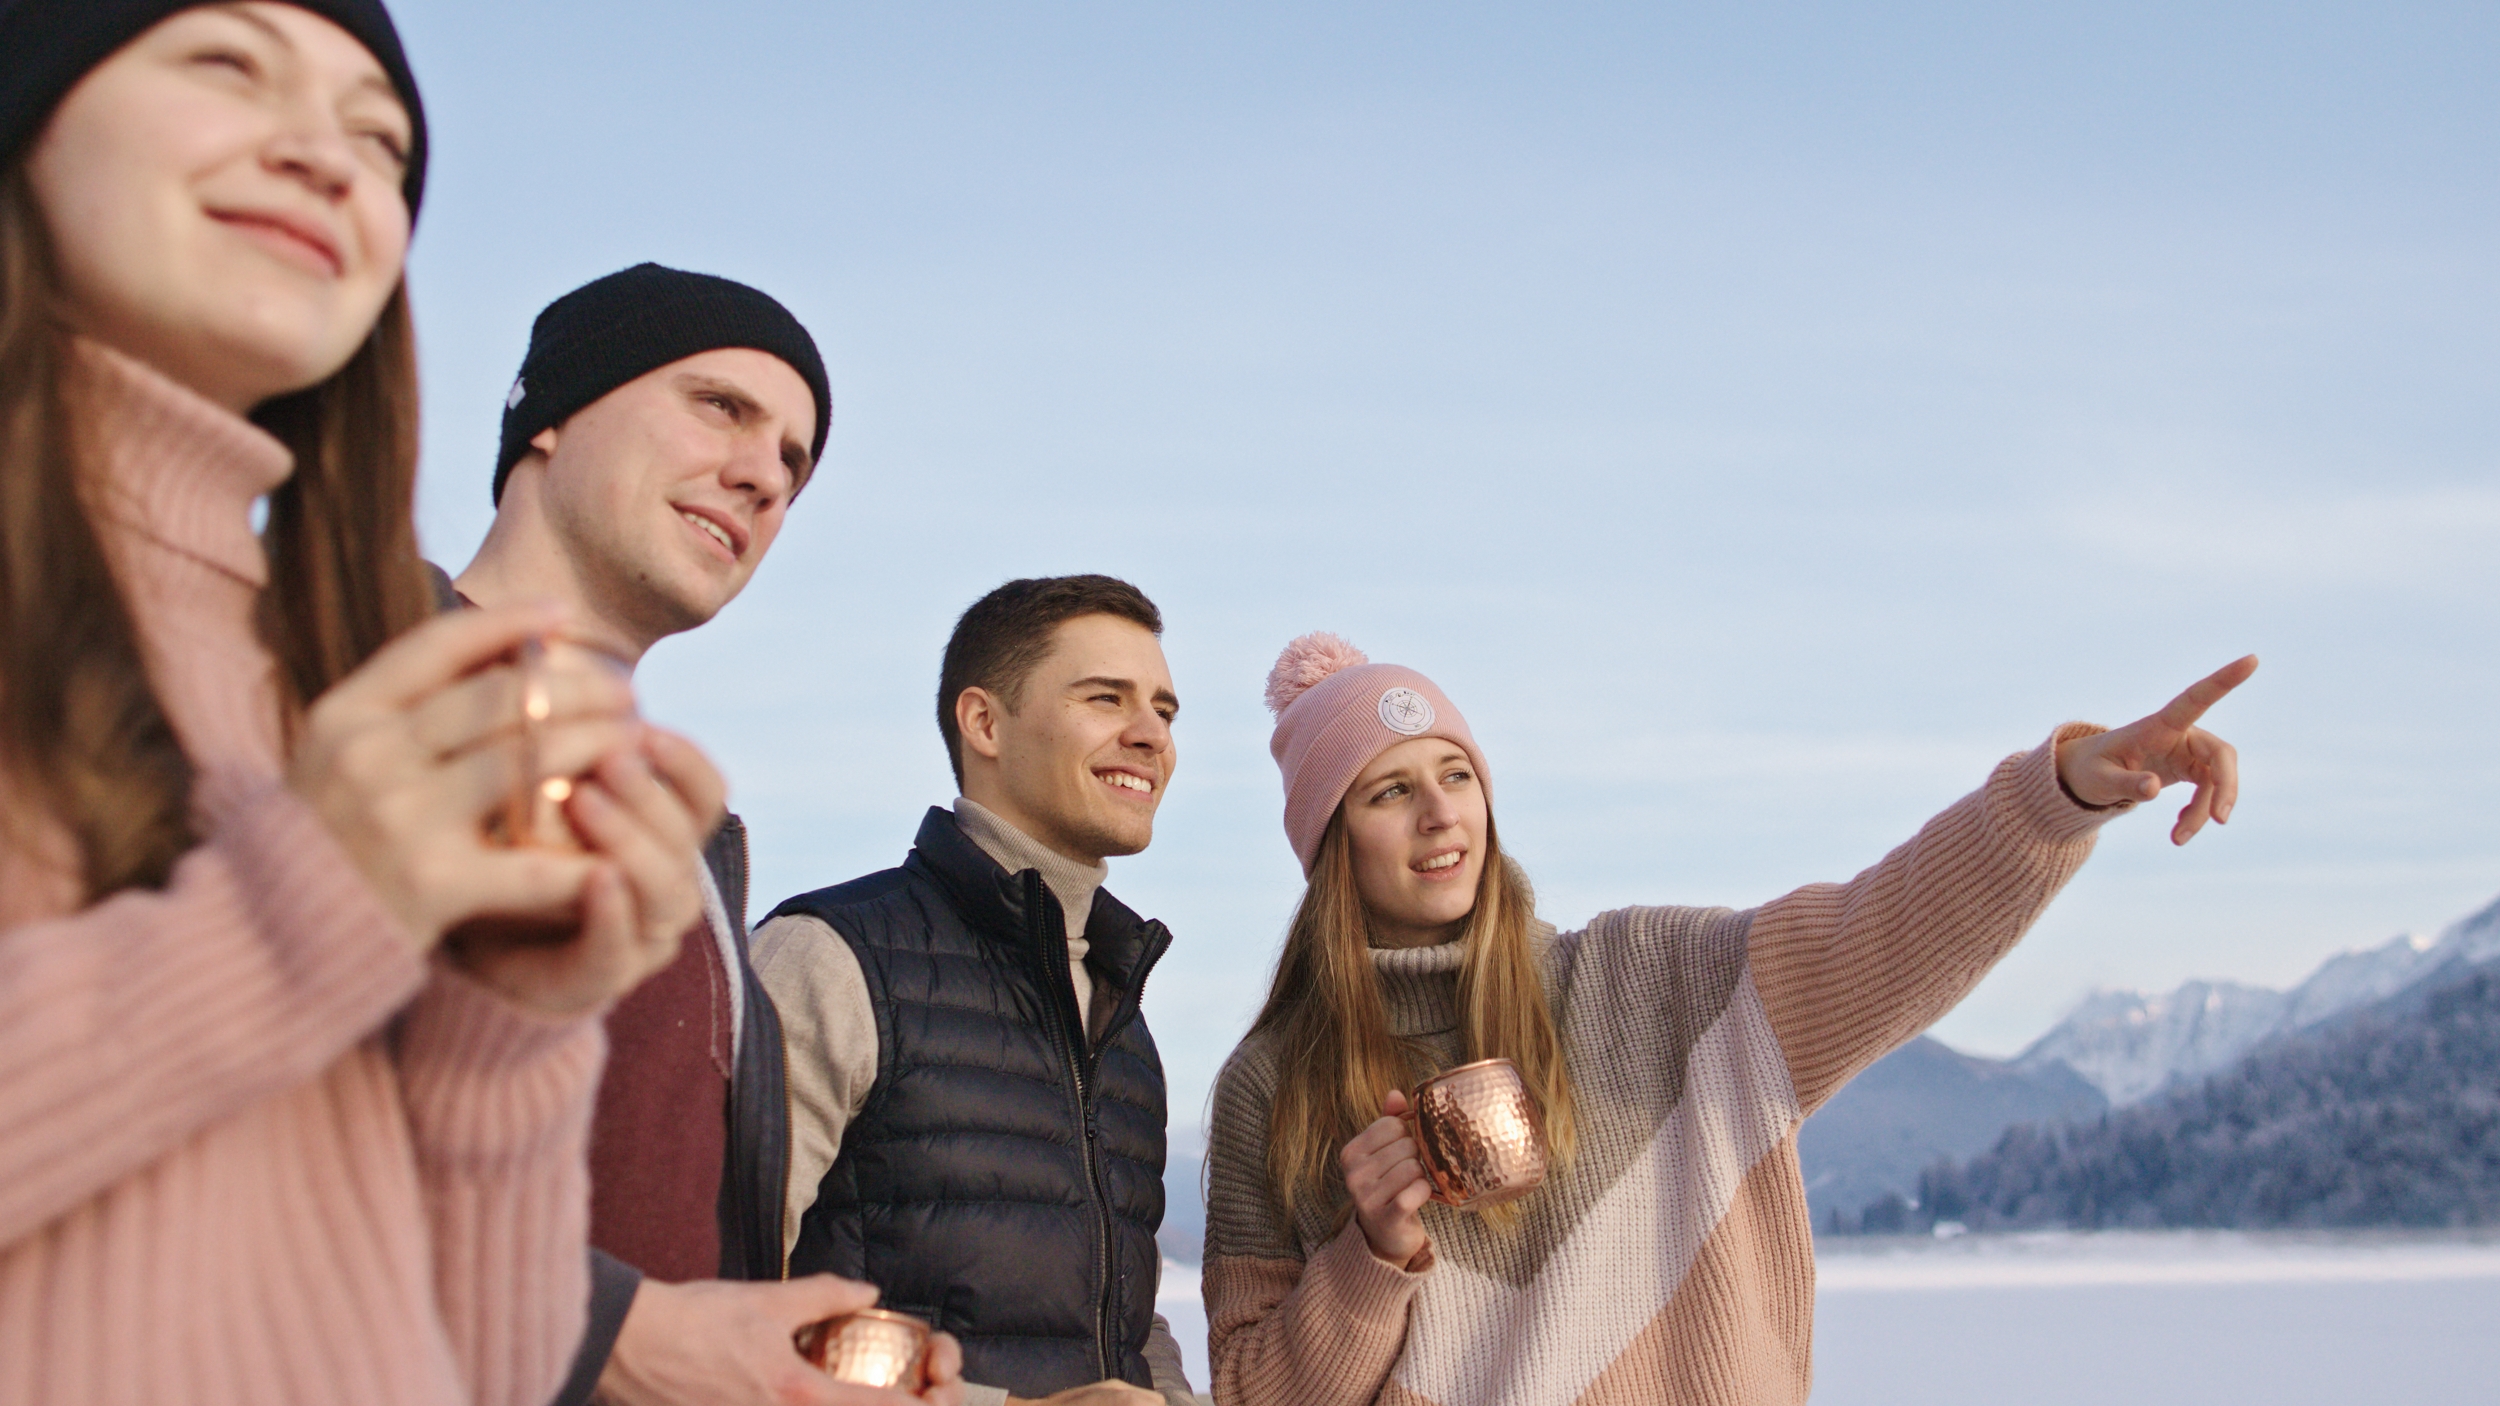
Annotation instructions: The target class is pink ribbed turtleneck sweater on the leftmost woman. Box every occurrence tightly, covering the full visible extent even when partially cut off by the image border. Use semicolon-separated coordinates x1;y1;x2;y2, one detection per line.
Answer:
0;343;603;1406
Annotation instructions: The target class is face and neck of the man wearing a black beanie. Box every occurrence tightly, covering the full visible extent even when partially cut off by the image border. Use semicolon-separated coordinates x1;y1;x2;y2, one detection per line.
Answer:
517;348;815;658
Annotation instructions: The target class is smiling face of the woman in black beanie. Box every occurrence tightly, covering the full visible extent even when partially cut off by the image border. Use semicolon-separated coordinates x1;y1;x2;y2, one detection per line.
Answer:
28;3;413;413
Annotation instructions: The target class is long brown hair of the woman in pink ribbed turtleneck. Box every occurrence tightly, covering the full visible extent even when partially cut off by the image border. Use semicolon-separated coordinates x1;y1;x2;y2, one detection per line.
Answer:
0;163;430;901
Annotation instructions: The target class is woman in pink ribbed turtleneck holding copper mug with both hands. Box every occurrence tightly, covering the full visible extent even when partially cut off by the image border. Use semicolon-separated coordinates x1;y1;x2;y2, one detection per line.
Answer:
0;0;720;1406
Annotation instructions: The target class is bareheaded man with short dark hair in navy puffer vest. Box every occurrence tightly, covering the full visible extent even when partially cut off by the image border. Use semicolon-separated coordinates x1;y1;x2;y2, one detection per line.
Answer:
755;575;1190;1406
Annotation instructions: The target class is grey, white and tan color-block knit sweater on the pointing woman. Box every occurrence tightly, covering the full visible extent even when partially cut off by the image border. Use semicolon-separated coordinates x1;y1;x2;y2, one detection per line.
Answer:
1203;726;2108;1406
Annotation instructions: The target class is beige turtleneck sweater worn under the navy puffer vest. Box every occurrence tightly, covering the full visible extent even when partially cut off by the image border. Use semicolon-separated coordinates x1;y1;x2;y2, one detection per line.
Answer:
755;796;1195;1406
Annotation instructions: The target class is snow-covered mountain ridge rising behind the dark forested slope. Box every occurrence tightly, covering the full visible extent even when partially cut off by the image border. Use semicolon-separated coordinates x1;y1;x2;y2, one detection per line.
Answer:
2013;898;2500;1106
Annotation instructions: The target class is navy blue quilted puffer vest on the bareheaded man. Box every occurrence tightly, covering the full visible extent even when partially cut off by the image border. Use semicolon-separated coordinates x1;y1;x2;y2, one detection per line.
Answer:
773;808;1173;1396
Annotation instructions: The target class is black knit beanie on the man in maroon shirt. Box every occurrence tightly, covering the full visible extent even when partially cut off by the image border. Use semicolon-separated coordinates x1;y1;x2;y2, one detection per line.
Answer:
495;263;833;503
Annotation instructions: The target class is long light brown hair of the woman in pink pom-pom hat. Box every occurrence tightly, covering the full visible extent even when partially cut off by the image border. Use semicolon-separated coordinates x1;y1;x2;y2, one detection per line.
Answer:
1250;806;1575;1226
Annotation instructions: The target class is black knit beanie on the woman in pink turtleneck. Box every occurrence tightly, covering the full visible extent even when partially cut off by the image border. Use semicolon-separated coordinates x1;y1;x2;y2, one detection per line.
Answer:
0;0;425;220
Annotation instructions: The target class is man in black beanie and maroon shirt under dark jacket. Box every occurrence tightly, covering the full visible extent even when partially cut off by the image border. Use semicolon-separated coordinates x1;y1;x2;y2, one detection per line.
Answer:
443;263;960;1406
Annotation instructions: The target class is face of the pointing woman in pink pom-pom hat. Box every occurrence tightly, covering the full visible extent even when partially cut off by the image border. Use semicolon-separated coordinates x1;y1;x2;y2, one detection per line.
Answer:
1345;738;1493;948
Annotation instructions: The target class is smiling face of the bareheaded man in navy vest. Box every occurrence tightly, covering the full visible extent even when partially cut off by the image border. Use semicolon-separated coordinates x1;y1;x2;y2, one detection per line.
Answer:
955;615;1180;863
